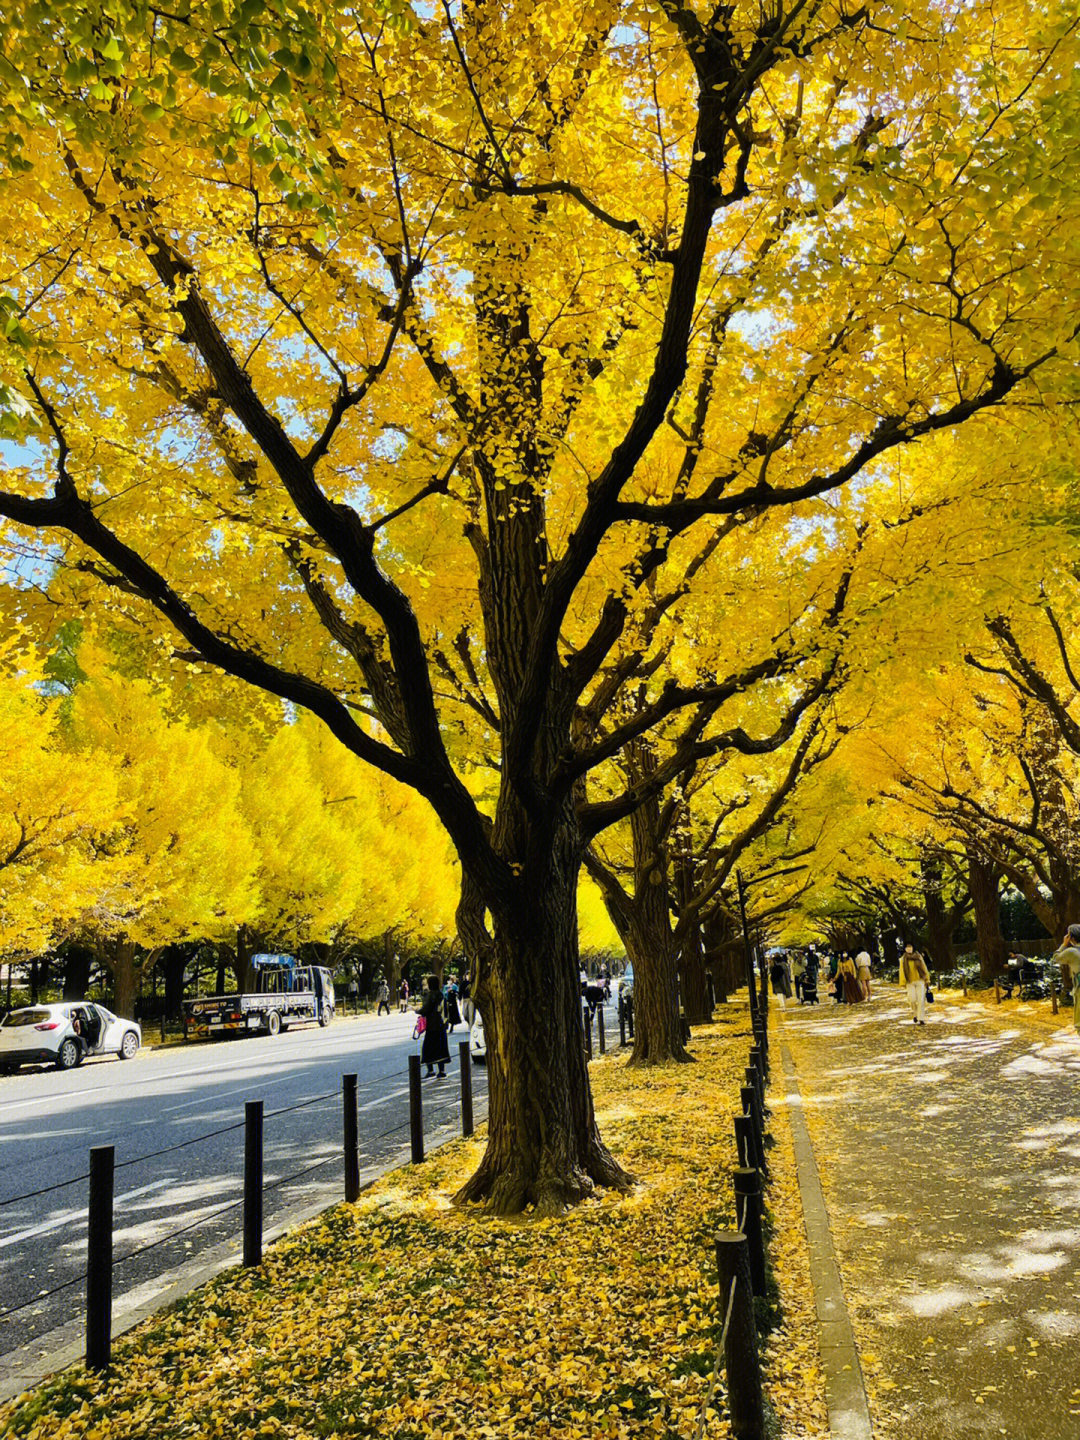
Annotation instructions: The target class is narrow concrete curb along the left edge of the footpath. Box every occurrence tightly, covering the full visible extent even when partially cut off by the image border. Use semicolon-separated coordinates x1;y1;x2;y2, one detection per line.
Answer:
780;1040;873;1440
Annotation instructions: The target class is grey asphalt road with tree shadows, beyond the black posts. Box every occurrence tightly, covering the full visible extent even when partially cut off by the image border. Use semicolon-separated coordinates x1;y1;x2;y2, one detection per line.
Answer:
0;1009;487;1355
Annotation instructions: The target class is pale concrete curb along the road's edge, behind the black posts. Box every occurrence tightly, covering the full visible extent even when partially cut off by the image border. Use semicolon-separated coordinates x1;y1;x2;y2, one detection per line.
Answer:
0;1104;487;1404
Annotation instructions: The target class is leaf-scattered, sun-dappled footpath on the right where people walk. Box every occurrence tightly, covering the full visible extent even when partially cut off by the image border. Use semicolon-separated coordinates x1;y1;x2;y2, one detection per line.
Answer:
780;985;1080;1440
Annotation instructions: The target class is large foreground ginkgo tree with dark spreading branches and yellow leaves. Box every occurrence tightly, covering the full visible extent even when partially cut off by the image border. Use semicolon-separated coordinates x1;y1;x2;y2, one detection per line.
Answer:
0;0;1080;1211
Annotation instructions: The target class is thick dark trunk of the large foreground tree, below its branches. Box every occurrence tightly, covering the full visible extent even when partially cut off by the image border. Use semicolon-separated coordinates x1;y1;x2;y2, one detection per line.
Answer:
456;834;631;1215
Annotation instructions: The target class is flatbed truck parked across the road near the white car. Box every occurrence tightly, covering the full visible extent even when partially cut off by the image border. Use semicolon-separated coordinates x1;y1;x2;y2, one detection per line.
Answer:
184;955;334;1040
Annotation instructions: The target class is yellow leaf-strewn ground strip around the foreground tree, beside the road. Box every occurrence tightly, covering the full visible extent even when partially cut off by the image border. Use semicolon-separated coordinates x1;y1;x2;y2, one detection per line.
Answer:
0;1007;827;1440
